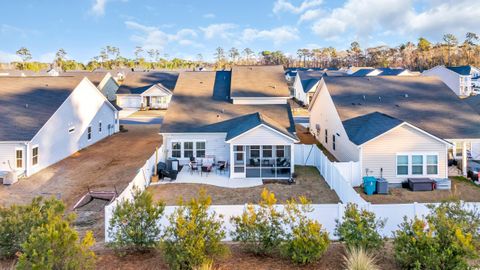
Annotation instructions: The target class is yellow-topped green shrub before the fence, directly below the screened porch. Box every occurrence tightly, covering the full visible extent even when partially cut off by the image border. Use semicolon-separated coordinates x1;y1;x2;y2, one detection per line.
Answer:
231;189;285;255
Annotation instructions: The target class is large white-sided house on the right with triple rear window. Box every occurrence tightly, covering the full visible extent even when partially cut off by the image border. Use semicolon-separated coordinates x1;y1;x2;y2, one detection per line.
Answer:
309;76;480;184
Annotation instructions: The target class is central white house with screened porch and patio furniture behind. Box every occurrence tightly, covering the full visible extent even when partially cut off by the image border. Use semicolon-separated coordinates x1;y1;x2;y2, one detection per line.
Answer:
160;66;298;181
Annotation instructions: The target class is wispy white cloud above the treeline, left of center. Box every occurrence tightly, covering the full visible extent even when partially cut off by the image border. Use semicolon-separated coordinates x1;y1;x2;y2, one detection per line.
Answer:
125;21;198;51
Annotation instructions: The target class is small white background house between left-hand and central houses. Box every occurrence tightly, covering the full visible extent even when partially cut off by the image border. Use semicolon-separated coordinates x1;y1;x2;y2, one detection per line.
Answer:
116;72;178;110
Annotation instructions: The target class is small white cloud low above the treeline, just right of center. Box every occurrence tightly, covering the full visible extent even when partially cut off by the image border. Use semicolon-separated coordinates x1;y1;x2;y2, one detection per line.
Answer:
242;26;299;46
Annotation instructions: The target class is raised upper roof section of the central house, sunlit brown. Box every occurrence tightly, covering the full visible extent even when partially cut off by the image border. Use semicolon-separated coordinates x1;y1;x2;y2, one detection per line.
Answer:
231;65;290;98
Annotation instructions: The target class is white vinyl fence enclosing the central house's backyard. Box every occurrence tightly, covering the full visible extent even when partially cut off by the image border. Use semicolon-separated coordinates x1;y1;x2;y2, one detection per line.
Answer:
105;145;480;242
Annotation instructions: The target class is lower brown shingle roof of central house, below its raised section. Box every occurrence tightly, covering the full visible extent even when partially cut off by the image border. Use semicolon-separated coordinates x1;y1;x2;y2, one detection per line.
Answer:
160;71;296;138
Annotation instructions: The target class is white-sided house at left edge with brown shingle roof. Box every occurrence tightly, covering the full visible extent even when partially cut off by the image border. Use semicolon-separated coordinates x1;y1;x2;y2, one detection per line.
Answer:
0;76;119;180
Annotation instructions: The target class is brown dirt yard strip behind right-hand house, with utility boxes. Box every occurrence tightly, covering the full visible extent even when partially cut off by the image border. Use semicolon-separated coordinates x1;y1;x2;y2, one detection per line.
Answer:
356;177;480;204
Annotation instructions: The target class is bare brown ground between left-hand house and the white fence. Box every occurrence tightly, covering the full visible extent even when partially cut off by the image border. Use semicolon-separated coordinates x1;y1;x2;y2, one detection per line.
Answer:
0;125;162;241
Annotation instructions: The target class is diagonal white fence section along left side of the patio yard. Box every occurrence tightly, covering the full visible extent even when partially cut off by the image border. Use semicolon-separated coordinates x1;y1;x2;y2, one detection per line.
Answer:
104;145;163;241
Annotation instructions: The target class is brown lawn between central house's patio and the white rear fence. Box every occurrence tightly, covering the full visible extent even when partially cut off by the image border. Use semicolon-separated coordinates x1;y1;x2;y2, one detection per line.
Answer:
148;166;340;205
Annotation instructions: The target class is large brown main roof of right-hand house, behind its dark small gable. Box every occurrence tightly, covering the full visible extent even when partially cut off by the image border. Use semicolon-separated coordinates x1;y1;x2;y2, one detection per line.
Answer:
316;76;480;139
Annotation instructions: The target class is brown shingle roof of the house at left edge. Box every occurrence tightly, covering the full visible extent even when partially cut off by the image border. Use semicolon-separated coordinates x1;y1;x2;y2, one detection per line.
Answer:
0;76;83;141
